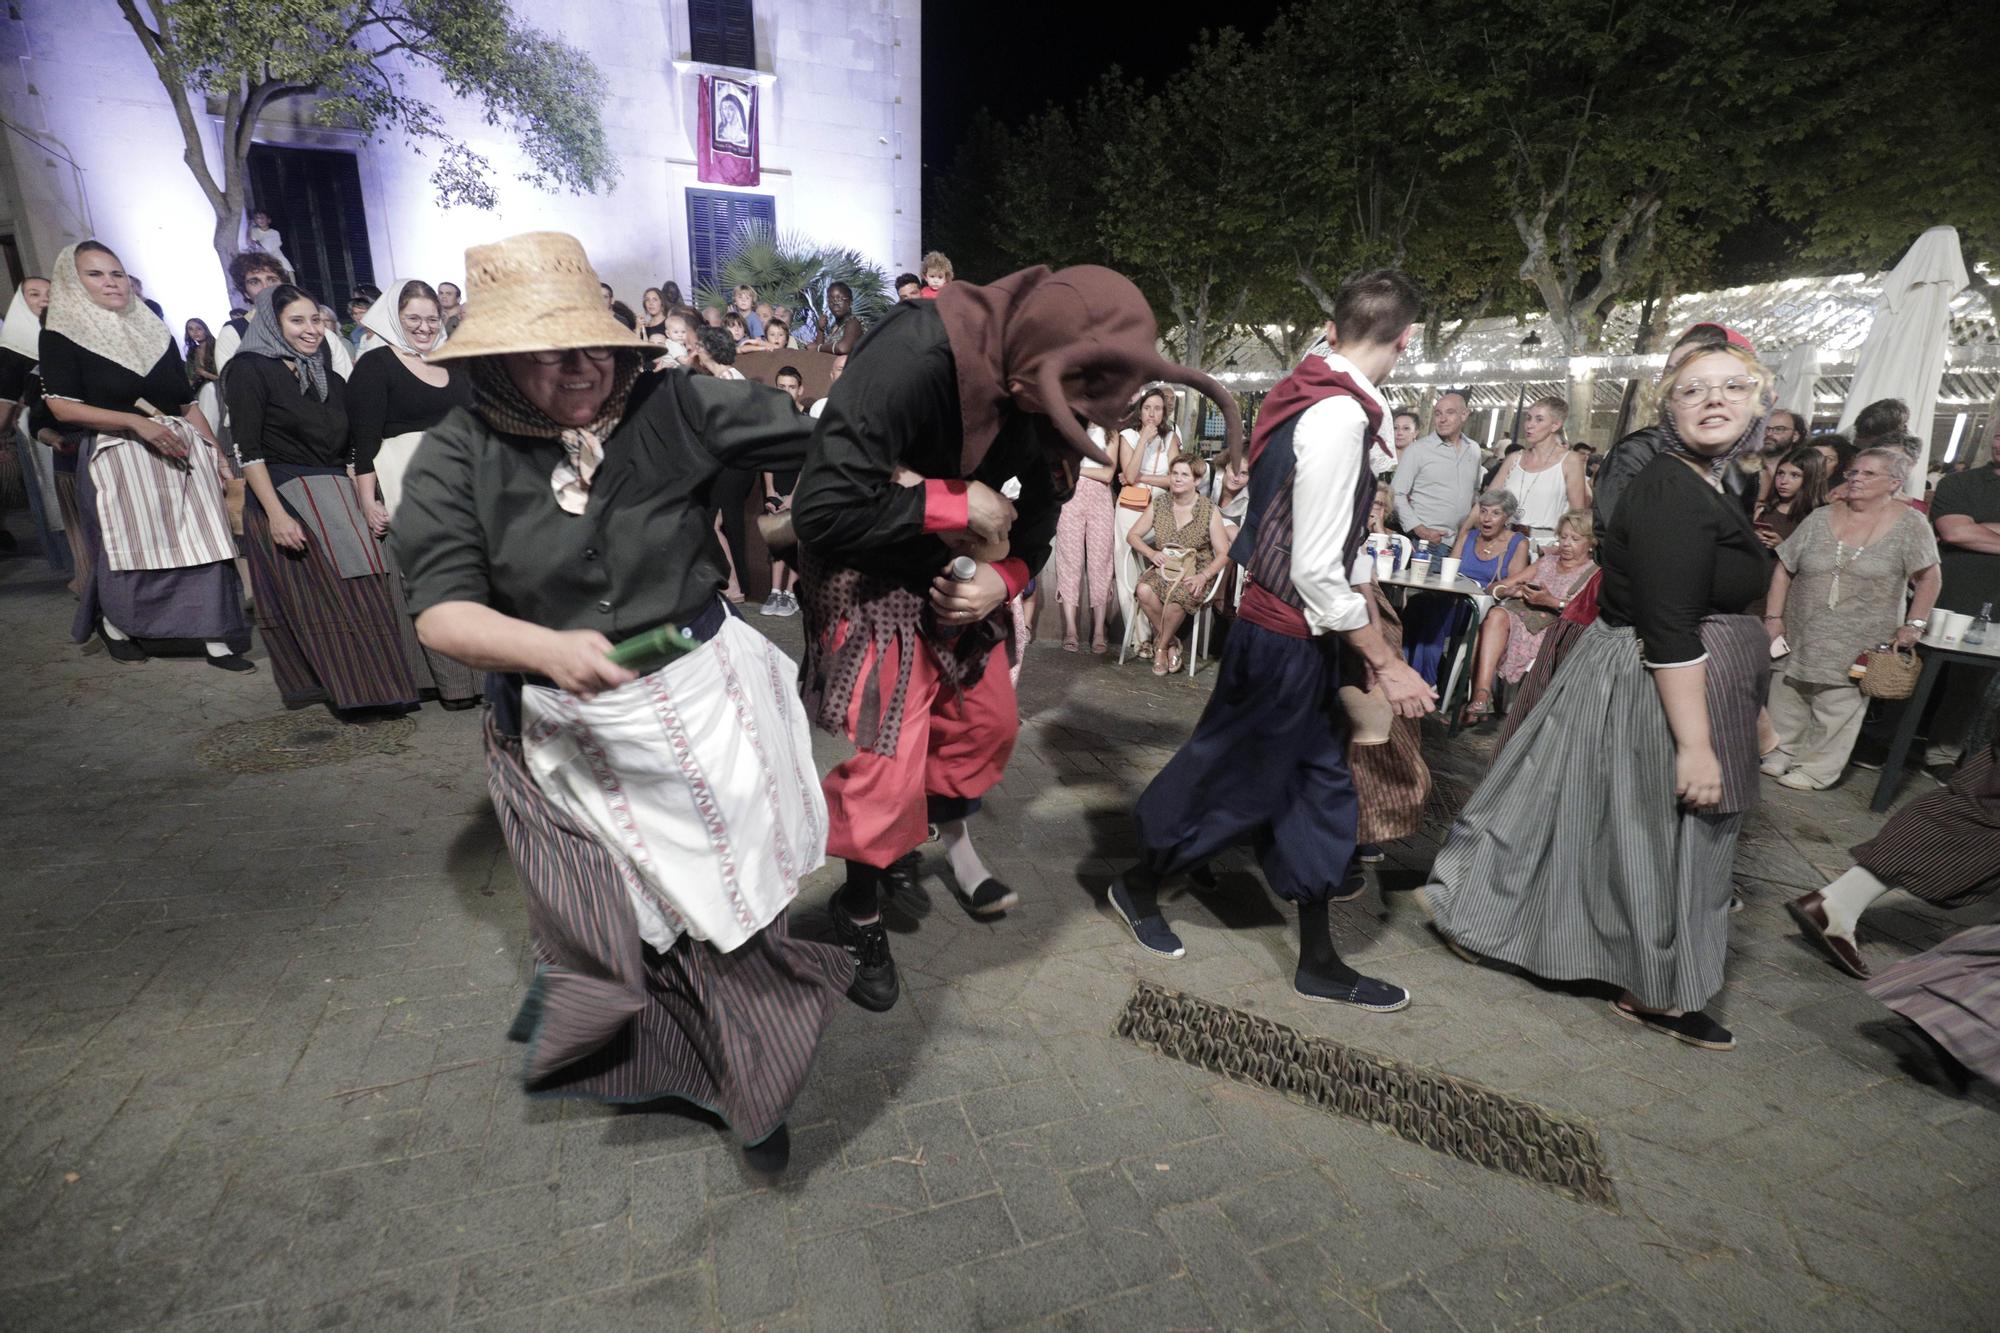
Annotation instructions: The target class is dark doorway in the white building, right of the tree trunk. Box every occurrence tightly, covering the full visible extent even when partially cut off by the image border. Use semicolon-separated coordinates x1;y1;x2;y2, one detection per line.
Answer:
248;144;374;314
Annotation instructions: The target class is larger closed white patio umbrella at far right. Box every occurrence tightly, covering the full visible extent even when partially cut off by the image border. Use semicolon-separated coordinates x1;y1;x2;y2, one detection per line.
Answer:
1840;226;1968;494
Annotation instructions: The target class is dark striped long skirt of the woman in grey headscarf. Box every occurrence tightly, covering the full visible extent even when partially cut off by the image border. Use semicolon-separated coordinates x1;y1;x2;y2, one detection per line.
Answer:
244;502;418;711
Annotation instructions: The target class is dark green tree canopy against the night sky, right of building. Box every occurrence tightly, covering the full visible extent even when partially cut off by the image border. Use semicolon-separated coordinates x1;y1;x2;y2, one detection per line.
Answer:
932;0;1952;364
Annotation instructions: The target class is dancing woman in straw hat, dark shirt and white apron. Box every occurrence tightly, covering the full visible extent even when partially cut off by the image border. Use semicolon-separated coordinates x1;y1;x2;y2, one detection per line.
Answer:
390;232;852;1169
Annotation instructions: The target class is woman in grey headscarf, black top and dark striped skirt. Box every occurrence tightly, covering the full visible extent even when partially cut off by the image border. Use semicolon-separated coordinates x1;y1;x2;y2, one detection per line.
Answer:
224;282;418;713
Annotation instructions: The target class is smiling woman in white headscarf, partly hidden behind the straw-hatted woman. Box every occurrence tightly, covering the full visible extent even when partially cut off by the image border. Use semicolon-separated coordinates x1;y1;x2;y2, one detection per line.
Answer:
348;280;480;711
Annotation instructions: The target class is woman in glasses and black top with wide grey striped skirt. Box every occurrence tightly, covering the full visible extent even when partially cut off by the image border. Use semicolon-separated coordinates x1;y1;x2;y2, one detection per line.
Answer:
1426;346;1772;1051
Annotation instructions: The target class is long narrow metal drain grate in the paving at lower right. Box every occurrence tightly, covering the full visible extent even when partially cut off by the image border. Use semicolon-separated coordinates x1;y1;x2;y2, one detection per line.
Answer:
1118;983;1618;1207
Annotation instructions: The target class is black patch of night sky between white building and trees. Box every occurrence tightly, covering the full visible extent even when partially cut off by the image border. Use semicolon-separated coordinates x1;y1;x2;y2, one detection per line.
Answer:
924;0;1284;178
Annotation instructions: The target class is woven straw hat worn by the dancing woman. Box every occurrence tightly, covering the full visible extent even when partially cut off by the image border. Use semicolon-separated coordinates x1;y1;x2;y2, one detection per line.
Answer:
426;232;660;362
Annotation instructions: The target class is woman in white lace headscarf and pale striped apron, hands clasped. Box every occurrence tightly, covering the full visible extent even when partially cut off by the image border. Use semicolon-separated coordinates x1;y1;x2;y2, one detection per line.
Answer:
42;240;254;671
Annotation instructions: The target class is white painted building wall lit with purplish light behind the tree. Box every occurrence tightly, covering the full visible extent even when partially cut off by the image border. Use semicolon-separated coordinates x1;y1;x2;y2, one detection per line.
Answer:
0;0;922;324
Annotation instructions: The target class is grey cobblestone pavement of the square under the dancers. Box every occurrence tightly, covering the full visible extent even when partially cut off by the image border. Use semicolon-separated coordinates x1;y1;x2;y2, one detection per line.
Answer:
0;544;2000;1331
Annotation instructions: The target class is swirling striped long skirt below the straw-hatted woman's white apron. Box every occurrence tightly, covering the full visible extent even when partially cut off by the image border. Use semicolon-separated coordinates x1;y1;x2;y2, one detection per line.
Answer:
486;715;854;1143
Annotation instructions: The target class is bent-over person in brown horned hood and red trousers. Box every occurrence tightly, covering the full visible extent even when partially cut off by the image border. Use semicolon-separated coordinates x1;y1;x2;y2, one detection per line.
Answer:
792;266;1242;1009
